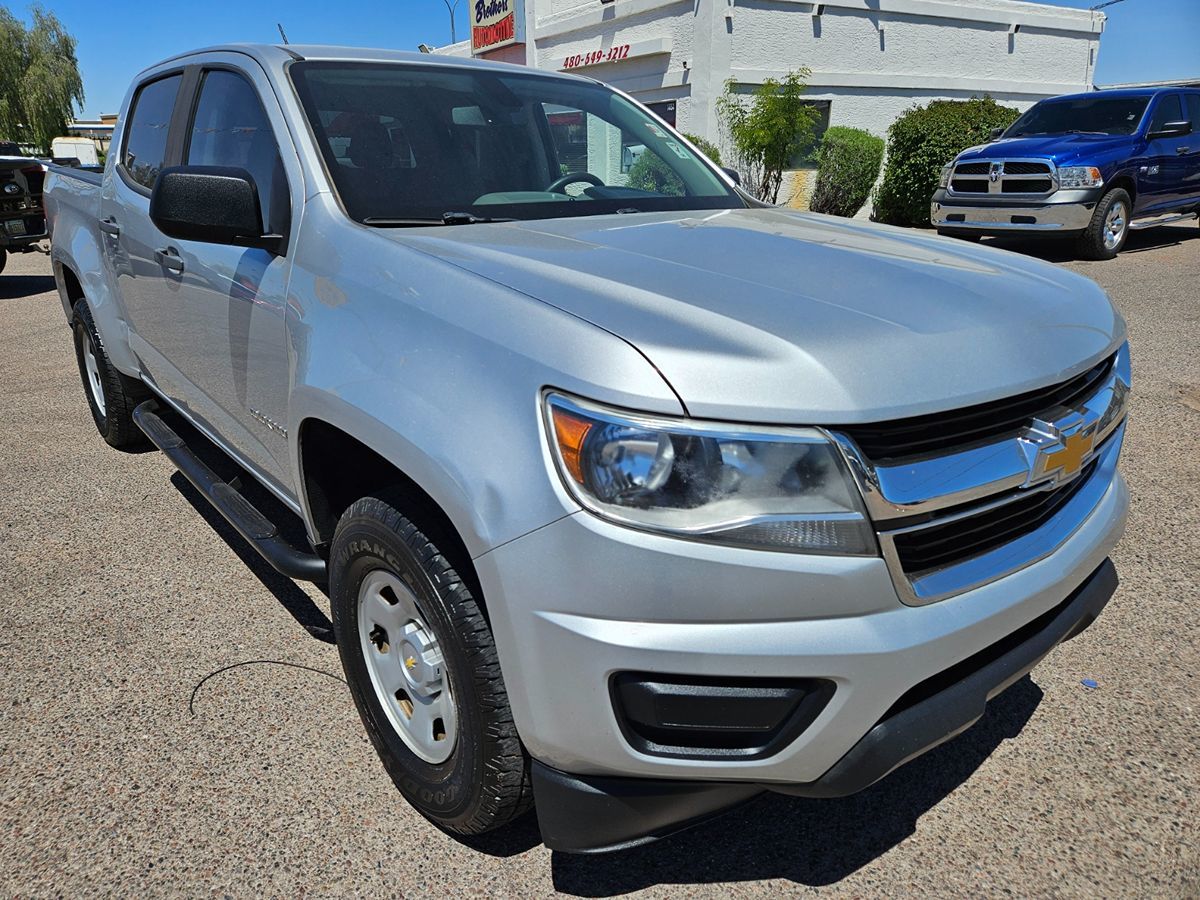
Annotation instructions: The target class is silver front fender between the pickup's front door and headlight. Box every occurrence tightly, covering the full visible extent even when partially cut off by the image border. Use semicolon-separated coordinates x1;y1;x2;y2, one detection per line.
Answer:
288;198;684;557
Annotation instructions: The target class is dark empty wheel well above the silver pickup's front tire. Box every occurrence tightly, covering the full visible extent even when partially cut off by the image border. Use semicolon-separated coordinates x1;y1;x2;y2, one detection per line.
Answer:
300;419;484;605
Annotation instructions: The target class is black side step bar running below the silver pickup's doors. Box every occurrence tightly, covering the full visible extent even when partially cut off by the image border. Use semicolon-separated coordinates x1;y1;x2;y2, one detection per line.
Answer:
133;400;328;582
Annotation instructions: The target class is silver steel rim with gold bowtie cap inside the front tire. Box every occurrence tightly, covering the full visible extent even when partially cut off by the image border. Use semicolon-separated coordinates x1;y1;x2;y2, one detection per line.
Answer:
358;569;458;763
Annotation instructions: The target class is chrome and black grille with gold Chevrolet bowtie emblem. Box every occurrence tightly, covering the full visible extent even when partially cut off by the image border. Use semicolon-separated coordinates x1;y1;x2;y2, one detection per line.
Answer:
829;346;1130;605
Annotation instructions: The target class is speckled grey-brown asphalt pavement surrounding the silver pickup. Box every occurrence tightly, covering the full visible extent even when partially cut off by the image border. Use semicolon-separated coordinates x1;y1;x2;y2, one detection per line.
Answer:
0;222;1200;898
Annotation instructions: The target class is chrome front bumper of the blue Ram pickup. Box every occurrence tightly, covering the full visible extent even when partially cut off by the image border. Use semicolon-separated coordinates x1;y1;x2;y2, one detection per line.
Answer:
929;188;1100;235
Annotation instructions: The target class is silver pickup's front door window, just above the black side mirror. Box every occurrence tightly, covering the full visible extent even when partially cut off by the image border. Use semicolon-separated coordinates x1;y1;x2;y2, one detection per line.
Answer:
185;68;289;234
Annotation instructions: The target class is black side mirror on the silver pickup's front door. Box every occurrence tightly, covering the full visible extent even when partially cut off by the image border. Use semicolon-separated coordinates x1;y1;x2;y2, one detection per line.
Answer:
150;166;283;253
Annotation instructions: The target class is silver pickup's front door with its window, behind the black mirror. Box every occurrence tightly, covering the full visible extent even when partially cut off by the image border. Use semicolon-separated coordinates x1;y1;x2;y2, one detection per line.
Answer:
165;54;302;486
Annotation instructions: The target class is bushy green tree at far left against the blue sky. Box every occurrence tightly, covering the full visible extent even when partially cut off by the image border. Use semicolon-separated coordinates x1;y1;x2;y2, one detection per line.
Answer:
0;4;83;154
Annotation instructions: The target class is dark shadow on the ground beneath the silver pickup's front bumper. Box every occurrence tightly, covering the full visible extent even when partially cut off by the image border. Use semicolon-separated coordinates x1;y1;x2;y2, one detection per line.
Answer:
552;676;1042;896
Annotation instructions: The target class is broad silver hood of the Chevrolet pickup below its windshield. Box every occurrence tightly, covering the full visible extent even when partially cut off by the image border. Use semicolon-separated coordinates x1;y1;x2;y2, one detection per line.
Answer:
385;209;1124;425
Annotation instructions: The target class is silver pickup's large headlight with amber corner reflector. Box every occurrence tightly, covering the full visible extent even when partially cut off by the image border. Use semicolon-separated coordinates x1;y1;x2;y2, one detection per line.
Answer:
545;394;876;556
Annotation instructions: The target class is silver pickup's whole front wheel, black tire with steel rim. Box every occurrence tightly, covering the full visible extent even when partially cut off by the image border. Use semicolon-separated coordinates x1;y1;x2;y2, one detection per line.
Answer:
329;491;533;835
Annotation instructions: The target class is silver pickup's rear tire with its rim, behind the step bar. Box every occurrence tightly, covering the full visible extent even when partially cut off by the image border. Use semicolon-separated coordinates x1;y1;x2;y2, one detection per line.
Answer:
72;300;150;450
